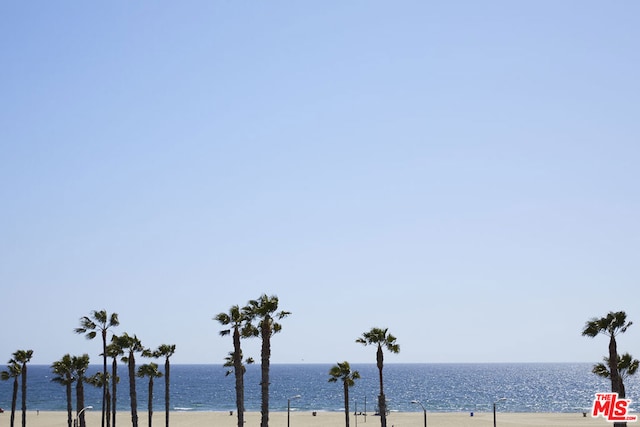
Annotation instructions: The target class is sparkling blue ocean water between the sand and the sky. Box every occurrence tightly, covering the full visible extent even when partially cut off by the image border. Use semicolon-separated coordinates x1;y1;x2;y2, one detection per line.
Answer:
0;363;640;413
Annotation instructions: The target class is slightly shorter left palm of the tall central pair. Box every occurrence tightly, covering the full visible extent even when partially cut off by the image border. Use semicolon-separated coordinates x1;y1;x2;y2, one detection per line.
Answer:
214;305;253;427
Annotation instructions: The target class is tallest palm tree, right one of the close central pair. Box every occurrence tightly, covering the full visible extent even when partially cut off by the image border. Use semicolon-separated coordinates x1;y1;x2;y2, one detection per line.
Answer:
242;294;291;427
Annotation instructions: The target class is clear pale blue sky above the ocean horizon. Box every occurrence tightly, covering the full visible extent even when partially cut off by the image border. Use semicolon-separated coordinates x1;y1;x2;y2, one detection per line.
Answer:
0;0;640;364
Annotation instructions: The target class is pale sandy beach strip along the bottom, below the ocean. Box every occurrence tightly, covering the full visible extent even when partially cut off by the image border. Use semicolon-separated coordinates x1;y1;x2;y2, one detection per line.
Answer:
7;410;612;427
